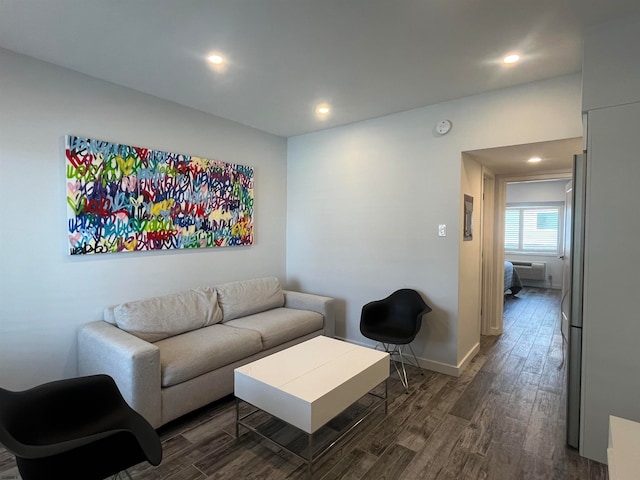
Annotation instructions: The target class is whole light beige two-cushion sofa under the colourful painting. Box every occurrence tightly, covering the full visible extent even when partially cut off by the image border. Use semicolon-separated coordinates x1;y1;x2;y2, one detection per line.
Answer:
78;277;335;428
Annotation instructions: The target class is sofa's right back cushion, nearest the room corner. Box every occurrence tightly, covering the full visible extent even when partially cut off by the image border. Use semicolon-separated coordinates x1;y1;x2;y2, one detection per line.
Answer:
216;277;284;322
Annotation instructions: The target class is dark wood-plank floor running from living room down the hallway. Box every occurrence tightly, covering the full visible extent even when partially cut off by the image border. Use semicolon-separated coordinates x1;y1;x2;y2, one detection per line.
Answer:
0;288;608;480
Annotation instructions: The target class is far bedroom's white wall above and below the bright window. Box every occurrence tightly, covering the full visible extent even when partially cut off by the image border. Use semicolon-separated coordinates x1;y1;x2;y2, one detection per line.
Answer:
505;178;564;289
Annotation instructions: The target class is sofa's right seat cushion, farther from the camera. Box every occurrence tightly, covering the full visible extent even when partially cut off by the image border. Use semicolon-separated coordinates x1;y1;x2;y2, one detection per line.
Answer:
224;308;324;350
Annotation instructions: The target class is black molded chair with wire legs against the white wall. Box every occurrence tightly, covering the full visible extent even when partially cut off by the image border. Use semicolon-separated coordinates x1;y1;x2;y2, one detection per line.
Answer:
360;288;431;393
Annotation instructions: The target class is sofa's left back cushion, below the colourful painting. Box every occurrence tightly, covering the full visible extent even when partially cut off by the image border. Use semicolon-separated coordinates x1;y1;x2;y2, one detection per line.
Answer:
105;287;222;342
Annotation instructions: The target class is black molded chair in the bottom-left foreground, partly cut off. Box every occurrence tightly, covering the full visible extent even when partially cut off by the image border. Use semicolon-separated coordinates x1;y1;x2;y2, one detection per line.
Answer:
0;375;162;480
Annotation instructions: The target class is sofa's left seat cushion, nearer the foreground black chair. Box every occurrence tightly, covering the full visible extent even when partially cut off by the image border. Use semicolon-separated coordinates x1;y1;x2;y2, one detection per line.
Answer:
155;324;262;387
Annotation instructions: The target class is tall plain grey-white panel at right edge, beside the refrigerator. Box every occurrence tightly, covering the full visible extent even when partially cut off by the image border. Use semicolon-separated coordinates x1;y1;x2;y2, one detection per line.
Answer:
580;16;640;462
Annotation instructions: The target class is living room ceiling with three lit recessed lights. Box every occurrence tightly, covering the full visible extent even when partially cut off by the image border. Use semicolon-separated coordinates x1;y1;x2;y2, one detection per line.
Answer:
0;0;640;137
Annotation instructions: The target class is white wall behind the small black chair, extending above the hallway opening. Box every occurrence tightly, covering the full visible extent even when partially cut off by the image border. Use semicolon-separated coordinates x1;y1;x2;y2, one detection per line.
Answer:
287;75;582;373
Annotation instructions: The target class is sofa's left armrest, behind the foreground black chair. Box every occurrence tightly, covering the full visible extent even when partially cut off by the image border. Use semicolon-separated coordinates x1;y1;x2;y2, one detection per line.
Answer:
78;321;162;428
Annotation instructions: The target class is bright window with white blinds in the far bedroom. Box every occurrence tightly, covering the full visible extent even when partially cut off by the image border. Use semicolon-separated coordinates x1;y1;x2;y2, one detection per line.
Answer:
504;204;562;255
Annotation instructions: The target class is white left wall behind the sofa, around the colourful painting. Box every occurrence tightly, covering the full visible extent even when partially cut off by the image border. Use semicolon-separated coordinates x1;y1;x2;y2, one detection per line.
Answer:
0;50;286;389
